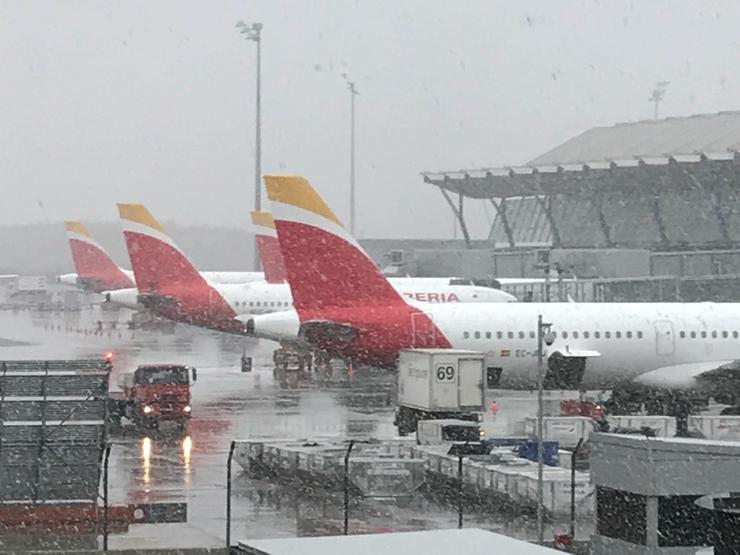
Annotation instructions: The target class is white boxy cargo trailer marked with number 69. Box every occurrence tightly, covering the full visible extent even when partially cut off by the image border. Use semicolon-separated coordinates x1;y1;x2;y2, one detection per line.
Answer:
396;349;486;435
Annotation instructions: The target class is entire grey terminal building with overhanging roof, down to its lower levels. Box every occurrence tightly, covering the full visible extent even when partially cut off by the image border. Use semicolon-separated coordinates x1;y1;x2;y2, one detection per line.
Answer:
408;111;740;300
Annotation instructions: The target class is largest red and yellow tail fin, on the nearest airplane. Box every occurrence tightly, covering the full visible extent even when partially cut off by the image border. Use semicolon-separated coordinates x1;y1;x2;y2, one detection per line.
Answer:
265;175;406;311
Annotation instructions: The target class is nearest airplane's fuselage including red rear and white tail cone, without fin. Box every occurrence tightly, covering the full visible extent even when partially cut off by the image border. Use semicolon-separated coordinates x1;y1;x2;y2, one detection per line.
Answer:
246;302;740;389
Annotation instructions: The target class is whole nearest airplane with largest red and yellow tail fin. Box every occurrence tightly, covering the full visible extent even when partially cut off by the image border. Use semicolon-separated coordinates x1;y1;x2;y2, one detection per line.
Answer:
243;176;740;396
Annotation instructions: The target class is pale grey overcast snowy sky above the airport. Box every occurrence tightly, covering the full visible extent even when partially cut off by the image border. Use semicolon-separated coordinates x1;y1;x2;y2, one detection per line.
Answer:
0;0;740;238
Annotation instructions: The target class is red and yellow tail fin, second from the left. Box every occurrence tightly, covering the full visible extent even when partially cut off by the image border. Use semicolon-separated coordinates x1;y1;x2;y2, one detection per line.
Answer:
118;203;208;293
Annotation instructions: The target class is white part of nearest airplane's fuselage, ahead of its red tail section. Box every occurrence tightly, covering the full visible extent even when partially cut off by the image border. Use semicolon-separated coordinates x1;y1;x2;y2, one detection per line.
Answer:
428;303;740;387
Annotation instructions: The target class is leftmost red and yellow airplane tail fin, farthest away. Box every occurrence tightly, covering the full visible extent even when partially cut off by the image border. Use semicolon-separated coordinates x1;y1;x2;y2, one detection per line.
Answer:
64;220;134;292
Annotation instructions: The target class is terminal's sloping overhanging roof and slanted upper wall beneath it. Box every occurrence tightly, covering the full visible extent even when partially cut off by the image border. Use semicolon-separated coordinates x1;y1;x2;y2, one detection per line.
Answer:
423;111;740;250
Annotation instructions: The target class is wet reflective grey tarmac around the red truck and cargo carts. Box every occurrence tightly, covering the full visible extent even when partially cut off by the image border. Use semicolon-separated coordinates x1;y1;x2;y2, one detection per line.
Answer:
0;308;590;548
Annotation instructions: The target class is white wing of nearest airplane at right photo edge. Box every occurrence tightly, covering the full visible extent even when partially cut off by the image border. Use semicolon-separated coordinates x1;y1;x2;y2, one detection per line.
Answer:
634;360;740;391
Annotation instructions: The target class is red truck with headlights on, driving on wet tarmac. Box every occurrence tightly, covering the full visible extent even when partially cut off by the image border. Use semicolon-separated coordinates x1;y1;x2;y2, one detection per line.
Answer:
108;364;197;428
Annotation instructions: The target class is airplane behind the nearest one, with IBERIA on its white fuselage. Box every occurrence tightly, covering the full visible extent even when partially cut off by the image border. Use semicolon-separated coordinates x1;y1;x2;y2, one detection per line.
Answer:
111;204;516;333
